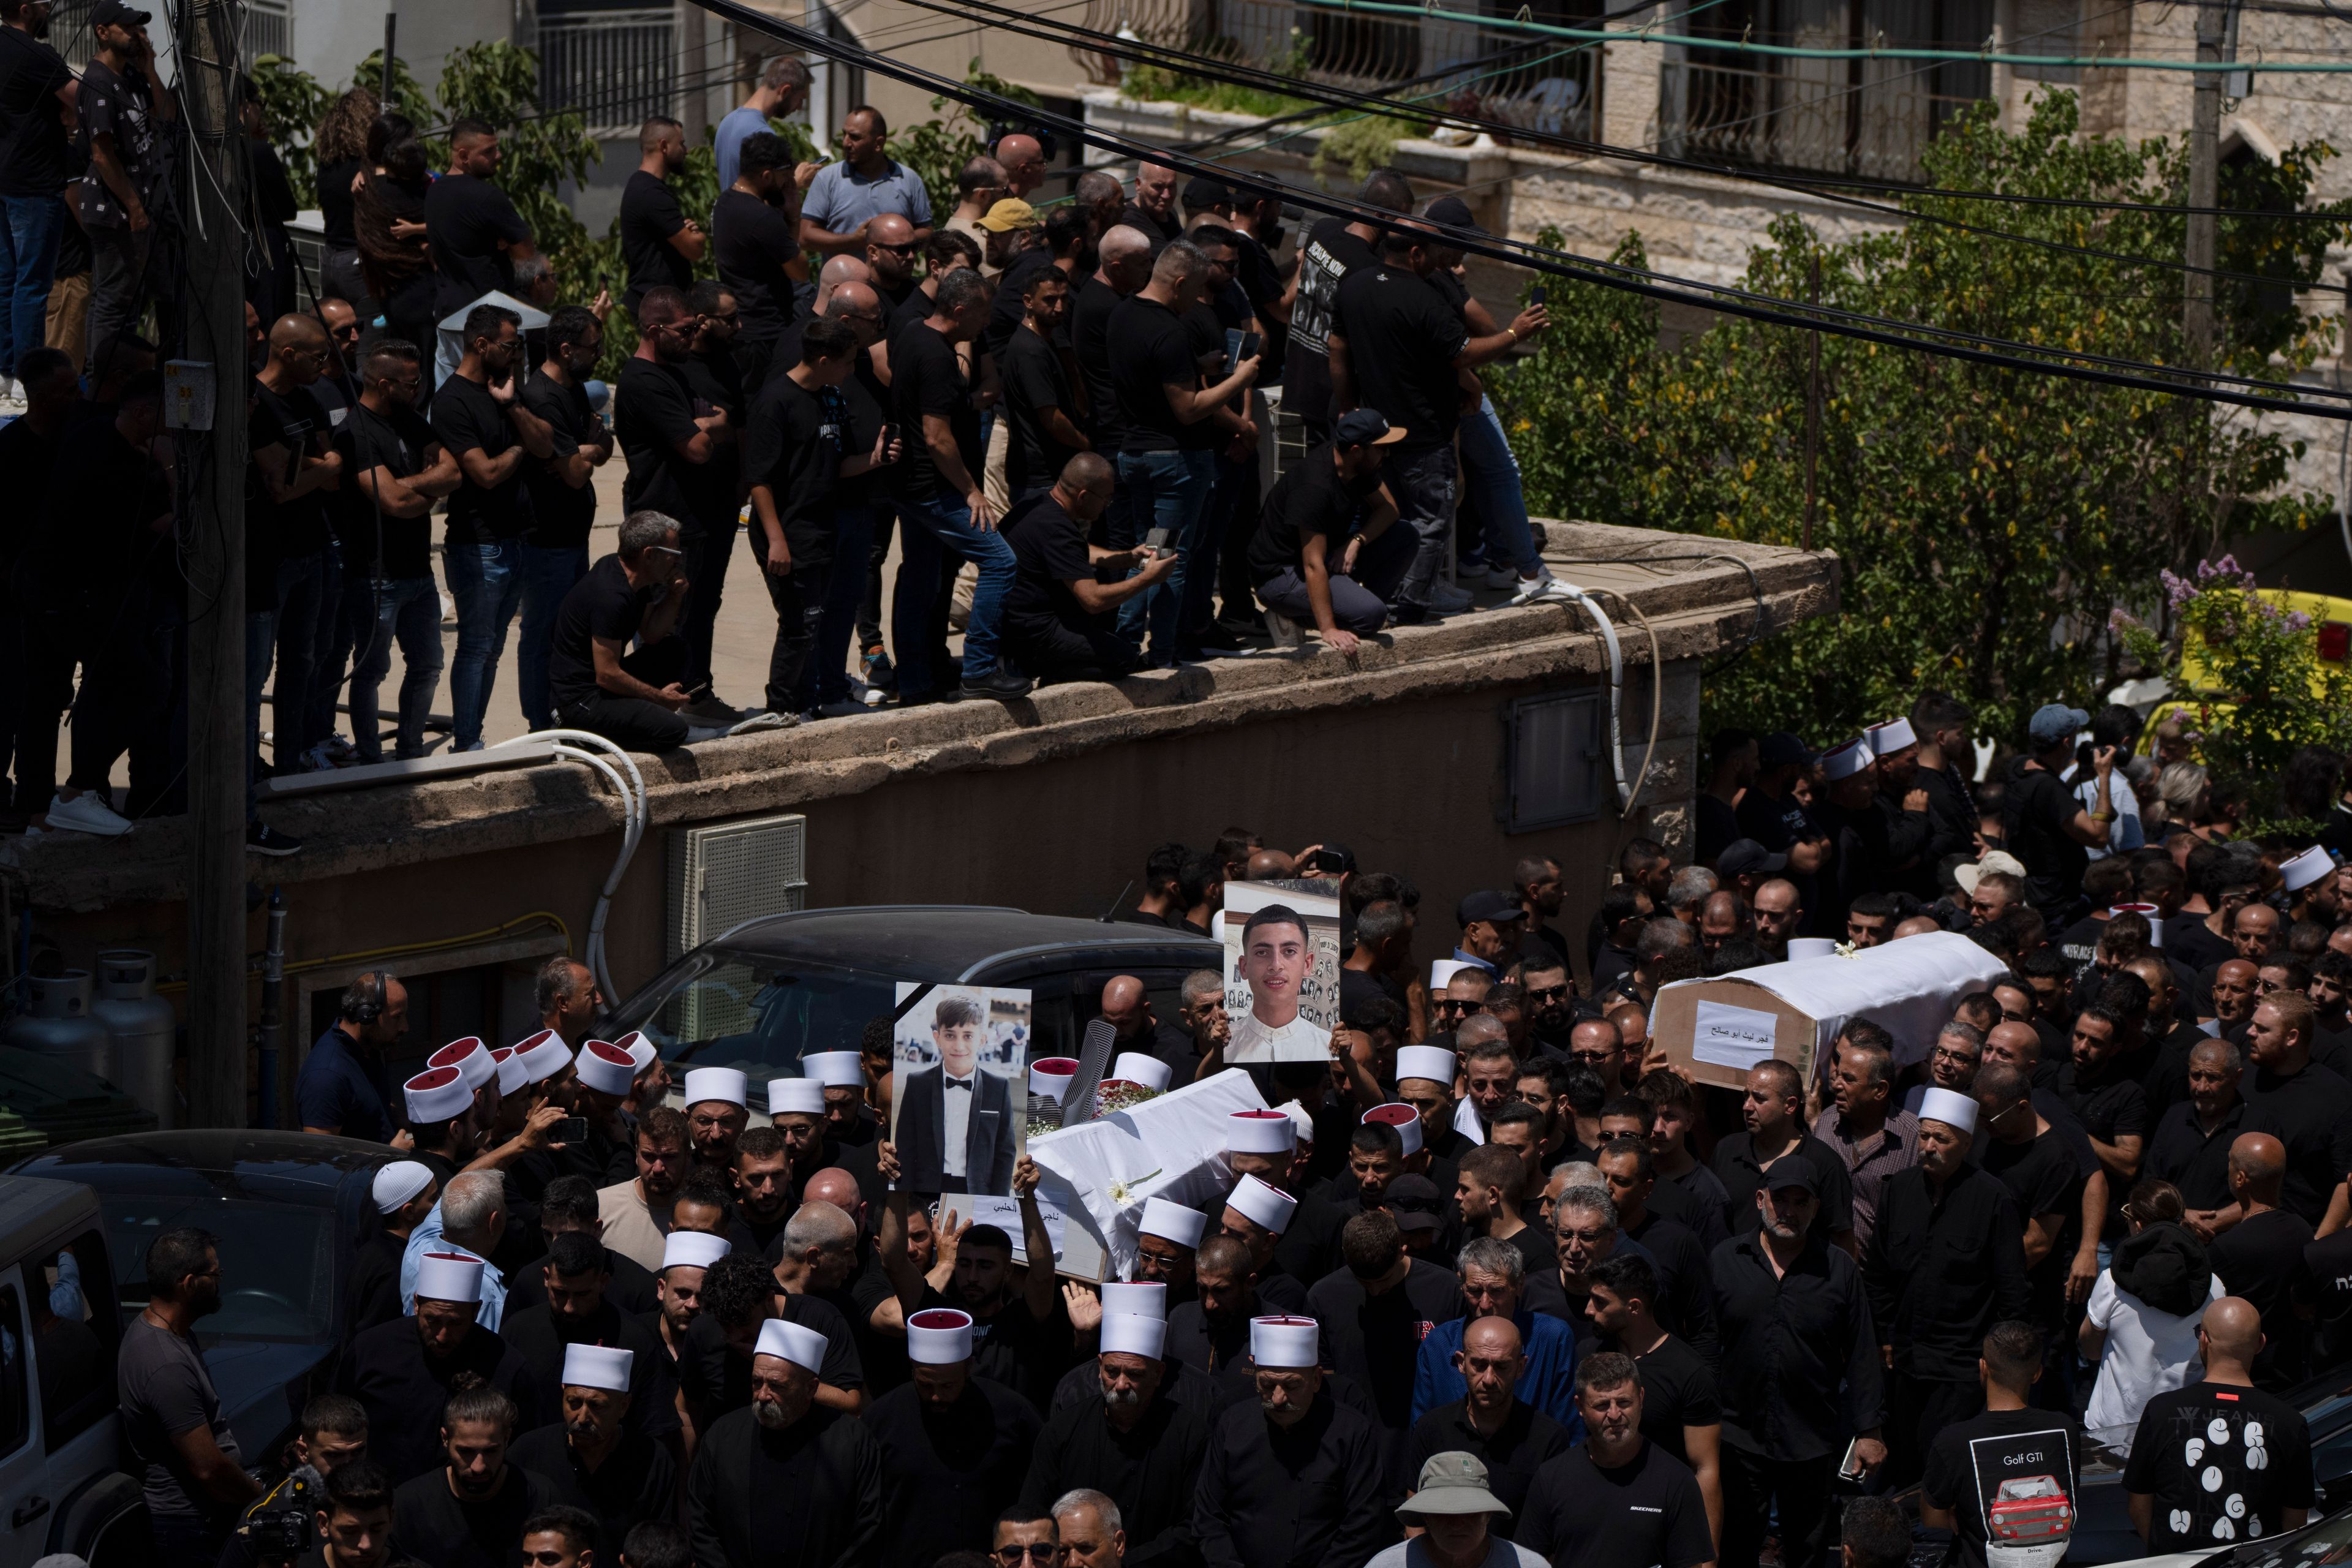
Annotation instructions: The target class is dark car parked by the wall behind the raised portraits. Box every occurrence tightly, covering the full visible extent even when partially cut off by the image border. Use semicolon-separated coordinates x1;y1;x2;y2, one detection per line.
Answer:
609;905;1226;1107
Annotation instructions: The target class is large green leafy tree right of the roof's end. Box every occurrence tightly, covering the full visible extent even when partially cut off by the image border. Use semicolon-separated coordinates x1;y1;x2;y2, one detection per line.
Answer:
1491;92;2352;752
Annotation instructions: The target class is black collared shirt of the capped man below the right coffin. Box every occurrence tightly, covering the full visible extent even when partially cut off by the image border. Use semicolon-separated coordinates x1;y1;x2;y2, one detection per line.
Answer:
1708;1223;1884;1460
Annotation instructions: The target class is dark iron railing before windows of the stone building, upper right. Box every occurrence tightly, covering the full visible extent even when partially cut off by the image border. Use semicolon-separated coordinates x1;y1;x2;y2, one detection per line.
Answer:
1658;0;1992;181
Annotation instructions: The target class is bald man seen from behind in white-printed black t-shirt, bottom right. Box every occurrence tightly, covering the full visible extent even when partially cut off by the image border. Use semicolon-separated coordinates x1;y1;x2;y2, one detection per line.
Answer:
2124;1295;2312;1551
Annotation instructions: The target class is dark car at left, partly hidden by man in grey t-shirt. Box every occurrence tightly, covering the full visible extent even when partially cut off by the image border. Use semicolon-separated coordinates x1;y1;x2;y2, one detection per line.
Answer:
0;1131;398;1476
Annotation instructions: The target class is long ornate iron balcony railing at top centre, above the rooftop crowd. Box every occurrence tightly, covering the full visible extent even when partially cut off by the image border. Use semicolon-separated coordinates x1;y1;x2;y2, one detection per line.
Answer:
1070;0;1602;137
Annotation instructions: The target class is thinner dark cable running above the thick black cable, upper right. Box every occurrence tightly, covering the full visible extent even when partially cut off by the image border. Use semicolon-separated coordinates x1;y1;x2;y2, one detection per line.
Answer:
931;0;2352;292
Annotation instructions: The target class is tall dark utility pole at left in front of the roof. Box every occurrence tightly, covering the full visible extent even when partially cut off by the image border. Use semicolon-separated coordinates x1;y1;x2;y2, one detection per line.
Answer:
179;0;249;1126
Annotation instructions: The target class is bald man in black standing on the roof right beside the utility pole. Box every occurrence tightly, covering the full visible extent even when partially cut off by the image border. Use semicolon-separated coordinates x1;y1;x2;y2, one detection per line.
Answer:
244;315;344;790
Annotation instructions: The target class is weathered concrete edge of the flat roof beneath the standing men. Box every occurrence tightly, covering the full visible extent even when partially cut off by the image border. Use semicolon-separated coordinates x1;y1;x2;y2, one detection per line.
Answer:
0;522;1837;910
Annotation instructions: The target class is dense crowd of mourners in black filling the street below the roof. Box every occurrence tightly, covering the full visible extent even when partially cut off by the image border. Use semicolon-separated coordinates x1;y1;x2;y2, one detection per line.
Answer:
96;696;2352;1568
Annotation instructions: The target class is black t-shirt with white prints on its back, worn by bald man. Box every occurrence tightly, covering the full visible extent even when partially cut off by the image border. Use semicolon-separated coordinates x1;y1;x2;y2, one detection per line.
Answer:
2124;1382;2312;1551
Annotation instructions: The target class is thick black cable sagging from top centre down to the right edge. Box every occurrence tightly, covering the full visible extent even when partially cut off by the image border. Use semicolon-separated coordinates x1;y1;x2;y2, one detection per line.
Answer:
698;0;2352;418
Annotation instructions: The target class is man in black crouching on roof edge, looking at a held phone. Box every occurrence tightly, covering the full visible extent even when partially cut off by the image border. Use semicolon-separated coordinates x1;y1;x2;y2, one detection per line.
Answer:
1005;451;1176;682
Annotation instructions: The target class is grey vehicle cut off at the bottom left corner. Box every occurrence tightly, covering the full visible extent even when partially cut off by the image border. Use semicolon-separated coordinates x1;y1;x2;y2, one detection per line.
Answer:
0;1175;146;1568
